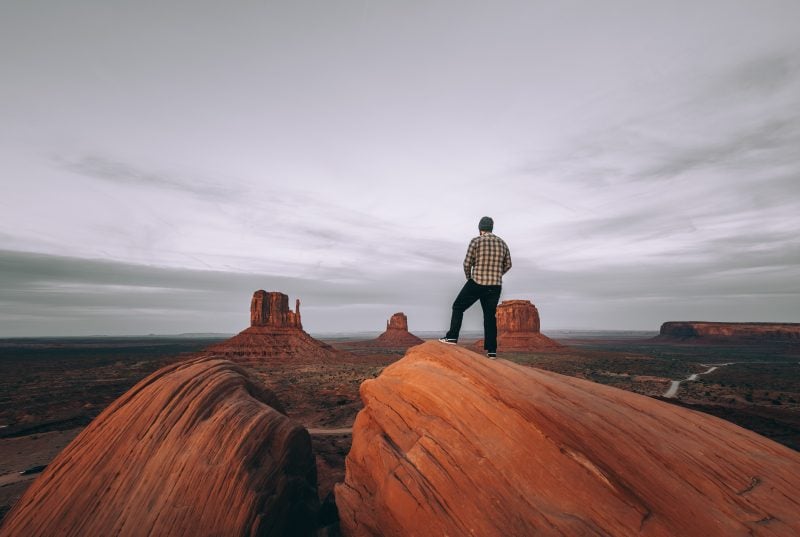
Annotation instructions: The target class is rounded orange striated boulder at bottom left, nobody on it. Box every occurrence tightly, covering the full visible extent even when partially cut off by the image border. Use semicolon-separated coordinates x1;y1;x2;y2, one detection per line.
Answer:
0;358;318;537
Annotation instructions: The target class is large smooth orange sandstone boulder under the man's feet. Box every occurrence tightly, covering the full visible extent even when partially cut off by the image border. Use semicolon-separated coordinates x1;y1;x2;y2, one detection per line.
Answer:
336;342;800;537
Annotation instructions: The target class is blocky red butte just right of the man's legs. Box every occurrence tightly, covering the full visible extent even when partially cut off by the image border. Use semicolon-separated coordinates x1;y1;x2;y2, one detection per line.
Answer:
475;300;561;352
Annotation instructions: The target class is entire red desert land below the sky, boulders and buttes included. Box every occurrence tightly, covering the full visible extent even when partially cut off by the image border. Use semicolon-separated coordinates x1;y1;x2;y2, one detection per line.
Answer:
0;291;800;535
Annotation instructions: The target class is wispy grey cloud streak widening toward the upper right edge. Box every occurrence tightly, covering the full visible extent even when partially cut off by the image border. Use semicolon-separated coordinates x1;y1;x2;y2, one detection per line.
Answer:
524;50;800;184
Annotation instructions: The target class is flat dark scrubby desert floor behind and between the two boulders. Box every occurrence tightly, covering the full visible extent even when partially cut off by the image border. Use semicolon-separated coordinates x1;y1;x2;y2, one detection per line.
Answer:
0;335;800;518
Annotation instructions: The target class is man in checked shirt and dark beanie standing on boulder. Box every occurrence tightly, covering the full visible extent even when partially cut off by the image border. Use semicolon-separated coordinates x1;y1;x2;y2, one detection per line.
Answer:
439;216;511;360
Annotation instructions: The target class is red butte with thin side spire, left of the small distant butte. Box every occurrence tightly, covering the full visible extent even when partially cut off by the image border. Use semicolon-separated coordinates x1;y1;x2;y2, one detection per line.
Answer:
206;290;342;363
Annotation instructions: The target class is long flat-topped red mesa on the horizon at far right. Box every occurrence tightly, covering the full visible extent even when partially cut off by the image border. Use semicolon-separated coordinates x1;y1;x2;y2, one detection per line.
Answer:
657;321;800;343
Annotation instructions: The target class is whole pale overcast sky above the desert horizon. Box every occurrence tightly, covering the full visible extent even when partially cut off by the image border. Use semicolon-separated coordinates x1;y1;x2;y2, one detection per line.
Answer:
0;0;800;336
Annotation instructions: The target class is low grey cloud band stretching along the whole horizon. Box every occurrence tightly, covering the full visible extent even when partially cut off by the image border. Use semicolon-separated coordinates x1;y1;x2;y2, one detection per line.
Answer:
0;243;800;336
